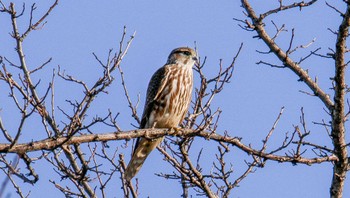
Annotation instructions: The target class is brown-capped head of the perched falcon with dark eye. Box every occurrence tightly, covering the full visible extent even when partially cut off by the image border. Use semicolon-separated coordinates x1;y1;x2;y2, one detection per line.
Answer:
167;47;198;66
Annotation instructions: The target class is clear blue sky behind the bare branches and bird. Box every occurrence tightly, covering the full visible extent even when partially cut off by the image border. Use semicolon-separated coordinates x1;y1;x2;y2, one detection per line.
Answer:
0;0;350;198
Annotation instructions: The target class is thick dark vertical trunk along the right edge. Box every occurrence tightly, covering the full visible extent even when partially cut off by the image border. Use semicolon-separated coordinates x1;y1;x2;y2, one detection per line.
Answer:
330;2;350;197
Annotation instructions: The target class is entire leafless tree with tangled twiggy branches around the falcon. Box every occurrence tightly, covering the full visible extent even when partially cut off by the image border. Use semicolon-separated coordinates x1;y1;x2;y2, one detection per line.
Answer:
0;0;350;197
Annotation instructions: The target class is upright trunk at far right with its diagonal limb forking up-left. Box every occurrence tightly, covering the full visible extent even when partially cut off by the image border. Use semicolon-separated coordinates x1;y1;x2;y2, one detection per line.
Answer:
238;0;350;197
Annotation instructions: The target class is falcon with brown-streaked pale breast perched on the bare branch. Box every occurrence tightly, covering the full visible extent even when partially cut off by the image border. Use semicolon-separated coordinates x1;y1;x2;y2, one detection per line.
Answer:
124;47;197;181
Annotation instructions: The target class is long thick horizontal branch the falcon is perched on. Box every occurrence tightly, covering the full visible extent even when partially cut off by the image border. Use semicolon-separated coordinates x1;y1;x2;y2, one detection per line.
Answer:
0;129;337;164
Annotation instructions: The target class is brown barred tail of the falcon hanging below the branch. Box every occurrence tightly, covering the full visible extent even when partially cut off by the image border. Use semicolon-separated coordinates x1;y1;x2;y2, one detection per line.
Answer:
124;137;164;181
